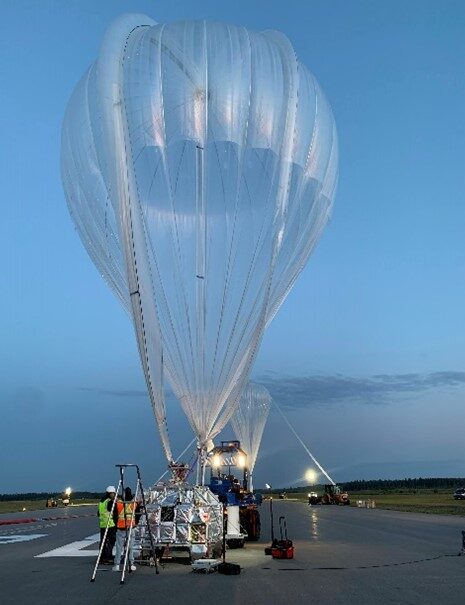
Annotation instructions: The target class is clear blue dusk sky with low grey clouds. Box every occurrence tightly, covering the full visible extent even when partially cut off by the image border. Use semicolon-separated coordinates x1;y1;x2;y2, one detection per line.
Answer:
0;0;465;492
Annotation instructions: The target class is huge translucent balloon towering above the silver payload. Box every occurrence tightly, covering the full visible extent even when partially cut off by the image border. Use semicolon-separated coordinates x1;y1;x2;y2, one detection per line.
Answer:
62;15;337;456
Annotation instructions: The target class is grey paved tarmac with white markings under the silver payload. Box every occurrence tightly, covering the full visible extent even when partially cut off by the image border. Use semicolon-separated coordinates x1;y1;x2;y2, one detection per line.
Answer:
0;500;465;605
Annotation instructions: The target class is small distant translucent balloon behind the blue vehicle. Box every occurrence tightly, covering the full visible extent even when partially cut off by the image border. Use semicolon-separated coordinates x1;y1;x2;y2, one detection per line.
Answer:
231;382;271;484
